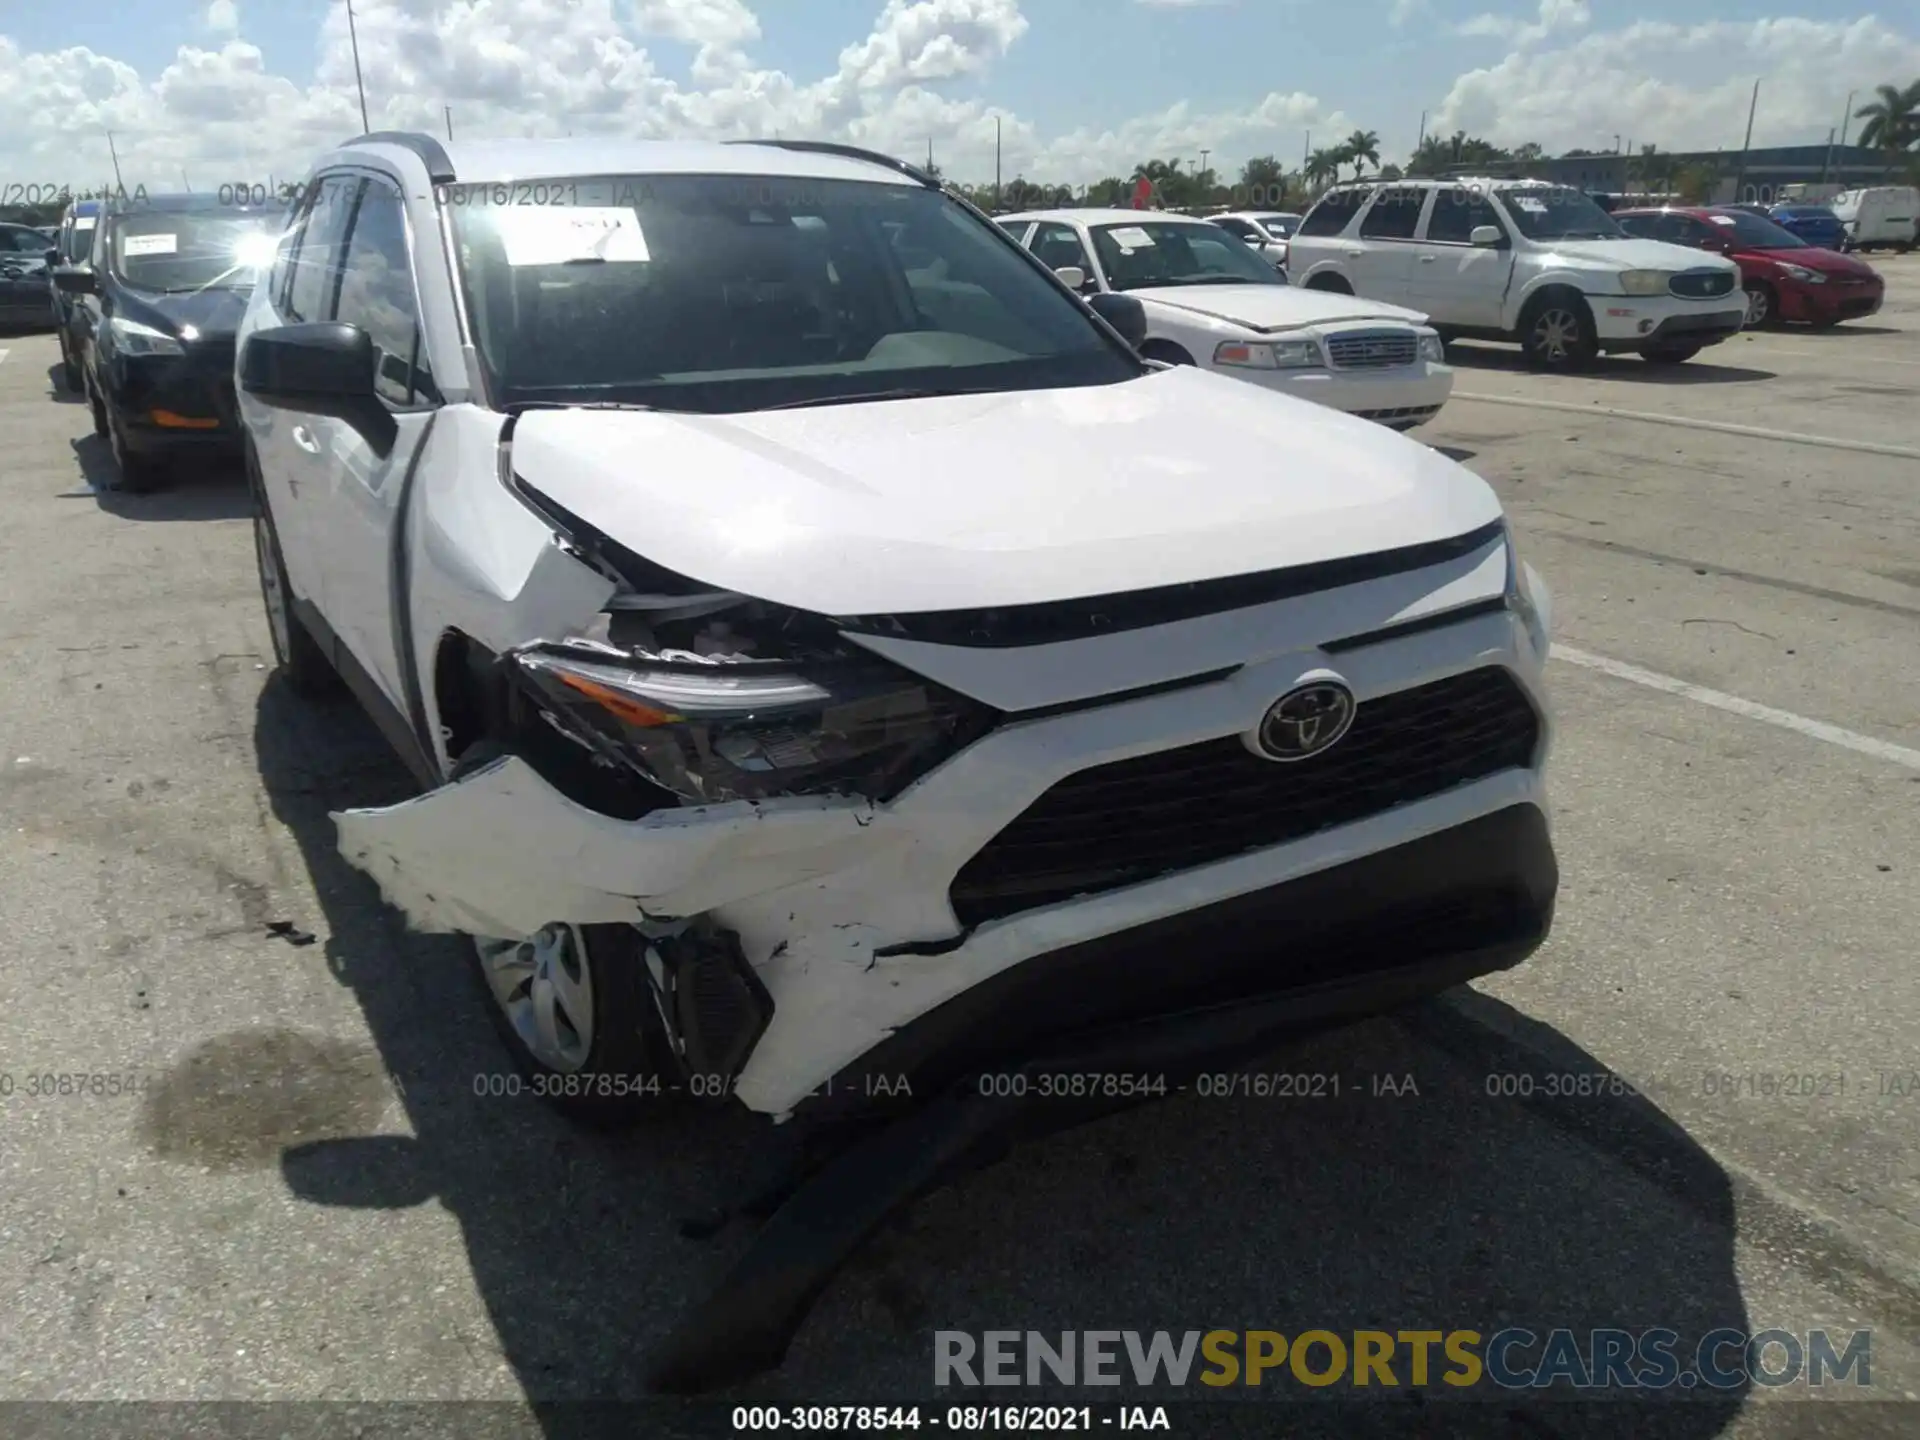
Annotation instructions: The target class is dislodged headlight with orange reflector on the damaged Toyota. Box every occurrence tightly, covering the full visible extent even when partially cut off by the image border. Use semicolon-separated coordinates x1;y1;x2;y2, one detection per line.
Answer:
511;637;996;804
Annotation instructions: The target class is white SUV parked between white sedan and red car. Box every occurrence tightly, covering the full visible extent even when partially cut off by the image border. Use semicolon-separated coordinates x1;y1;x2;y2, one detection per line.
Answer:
1288;179;1745;369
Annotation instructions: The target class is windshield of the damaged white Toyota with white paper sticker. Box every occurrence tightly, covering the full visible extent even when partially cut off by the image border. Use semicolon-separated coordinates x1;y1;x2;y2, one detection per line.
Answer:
444;175;1140;413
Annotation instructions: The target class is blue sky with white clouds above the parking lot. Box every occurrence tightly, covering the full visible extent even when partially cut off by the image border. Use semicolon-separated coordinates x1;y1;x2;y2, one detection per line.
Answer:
0;0;1920;184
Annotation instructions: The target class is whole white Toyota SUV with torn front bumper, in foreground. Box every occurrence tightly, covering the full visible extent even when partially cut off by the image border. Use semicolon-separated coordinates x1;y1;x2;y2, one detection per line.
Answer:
236;134;1557;1388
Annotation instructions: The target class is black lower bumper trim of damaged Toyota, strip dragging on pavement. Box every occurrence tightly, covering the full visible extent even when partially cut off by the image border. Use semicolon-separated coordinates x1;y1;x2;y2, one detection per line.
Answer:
651;804;1559;1394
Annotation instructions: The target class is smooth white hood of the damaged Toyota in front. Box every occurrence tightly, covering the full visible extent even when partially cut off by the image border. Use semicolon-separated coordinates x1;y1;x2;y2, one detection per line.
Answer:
513;367;1500;614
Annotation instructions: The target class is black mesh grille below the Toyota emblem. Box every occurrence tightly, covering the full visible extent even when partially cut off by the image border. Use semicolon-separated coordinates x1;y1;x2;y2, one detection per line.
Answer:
948;666;1540;925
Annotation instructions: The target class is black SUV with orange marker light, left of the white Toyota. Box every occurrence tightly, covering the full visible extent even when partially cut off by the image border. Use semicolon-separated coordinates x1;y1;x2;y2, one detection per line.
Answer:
54;194;286;492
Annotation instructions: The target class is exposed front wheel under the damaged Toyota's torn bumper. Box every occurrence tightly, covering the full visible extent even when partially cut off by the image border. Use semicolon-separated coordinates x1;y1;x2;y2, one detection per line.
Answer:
449;743;687;1131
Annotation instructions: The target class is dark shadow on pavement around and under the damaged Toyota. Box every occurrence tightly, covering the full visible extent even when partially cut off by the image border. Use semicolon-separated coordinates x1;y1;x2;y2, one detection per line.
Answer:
253;682;1747;1440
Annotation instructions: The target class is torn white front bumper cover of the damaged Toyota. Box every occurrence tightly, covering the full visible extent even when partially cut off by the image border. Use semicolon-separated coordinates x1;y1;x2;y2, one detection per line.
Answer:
336;568;1549;1116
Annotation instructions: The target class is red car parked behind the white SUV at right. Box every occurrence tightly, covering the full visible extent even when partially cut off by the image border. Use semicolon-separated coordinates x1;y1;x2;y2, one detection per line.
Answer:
1613;205;1887;330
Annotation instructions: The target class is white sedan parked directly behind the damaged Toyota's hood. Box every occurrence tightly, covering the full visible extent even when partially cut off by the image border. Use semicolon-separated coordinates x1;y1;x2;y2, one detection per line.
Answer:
995;209;1453;430
